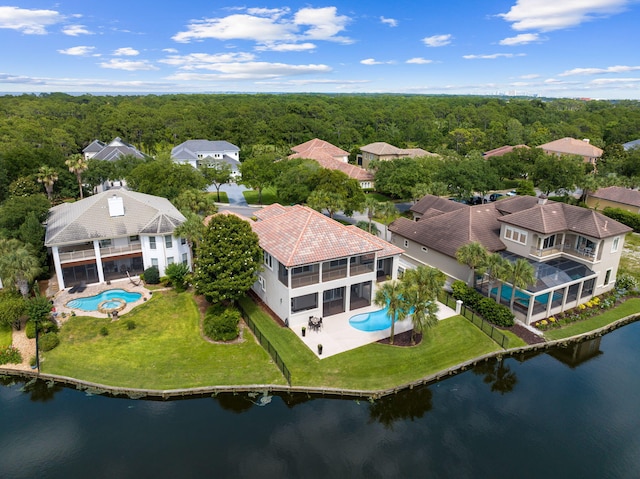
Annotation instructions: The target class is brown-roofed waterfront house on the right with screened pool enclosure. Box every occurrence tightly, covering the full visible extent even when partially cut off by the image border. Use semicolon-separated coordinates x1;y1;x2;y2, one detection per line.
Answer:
389;195;631;324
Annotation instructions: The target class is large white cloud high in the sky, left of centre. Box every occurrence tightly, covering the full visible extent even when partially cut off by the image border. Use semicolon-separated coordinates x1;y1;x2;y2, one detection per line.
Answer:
172;7;351;45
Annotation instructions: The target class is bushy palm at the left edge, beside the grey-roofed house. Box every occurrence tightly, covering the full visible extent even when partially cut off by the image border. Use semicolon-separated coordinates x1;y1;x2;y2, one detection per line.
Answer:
0;239;41;298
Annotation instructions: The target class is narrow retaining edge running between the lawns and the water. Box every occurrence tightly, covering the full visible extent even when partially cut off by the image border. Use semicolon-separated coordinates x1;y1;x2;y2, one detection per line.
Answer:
0;313;640;400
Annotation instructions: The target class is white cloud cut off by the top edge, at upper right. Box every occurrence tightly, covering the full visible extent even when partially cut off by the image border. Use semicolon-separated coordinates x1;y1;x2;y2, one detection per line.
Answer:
498;0;633;32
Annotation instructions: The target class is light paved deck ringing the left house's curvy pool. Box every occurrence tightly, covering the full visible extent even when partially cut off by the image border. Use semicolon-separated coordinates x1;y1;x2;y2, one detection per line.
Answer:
53;278;151;324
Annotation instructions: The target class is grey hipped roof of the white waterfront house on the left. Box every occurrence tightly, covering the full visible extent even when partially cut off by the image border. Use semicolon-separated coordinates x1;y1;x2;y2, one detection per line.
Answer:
45;189;185;246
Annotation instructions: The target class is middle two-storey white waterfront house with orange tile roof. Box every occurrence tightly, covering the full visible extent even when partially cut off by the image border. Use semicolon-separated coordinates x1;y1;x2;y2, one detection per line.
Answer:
251;203;402;326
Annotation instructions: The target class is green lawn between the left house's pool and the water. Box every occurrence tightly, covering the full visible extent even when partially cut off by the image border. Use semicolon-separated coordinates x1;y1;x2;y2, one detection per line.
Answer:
42;291;286;389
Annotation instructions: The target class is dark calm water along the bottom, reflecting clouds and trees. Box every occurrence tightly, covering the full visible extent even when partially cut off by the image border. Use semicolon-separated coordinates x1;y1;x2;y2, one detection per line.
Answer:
0;323;640;479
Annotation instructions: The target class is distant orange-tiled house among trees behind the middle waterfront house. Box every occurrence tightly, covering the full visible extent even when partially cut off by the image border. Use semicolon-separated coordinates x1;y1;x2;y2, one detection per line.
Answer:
288;138;374;188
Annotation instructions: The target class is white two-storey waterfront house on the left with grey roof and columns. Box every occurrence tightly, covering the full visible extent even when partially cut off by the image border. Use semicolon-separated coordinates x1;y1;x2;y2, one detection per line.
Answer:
45;189;191;289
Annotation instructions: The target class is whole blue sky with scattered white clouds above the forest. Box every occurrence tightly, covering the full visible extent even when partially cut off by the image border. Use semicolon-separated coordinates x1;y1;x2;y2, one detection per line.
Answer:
0;0;640;99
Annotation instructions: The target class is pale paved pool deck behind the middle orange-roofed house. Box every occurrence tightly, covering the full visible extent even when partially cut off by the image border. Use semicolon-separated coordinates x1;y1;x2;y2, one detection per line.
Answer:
291;303;456;359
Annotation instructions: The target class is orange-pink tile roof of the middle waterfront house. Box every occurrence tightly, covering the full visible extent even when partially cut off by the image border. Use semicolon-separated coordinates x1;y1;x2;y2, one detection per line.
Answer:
251;204;399;267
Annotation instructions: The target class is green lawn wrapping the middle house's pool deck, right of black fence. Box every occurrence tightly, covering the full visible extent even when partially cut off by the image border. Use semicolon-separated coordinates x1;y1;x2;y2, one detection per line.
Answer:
241;298;501;389
